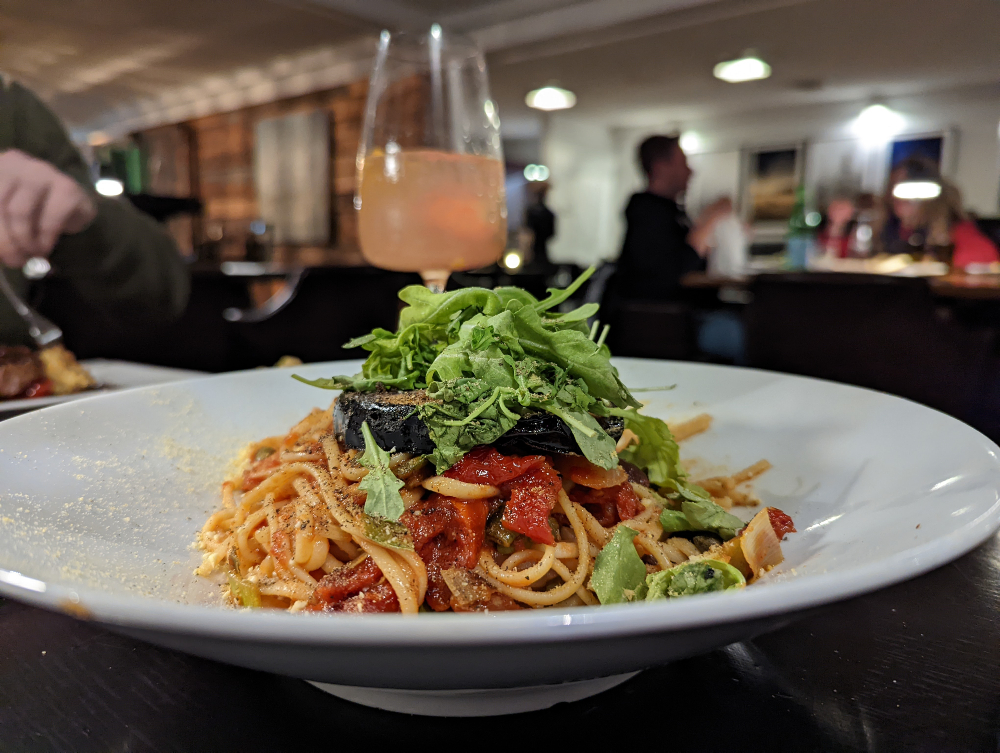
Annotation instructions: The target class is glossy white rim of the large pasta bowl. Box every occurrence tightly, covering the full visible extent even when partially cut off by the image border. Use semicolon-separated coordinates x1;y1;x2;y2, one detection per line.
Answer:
0;358;1000;648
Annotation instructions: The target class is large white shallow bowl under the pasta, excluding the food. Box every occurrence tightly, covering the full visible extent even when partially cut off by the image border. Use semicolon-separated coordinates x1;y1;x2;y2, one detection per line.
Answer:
0;360;1000;714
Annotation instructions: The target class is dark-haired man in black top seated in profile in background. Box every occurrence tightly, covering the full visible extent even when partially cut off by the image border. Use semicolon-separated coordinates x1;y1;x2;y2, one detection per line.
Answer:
615;136;732;300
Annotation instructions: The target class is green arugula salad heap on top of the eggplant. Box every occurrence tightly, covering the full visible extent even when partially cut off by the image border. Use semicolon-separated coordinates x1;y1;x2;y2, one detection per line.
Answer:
296;269;700;476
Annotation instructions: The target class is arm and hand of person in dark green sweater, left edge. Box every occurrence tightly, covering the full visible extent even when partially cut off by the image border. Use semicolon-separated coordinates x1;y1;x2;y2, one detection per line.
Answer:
0;78;190;345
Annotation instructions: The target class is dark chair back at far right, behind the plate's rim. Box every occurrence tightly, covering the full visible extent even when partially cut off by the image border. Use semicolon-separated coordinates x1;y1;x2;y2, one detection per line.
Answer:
746;274;994;425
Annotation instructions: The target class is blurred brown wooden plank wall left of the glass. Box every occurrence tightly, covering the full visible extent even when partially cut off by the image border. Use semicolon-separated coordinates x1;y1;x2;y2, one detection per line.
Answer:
134;81;376;264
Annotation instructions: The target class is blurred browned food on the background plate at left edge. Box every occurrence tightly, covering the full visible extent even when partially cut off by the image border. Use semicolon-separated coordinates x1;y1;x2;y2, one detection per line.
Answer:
0;345;97;400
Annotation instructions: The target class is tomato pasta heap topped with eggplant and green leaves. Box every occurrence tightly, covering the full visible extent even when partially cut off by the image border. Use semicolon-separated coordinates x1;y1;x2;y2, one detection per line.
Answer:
198;271;795;613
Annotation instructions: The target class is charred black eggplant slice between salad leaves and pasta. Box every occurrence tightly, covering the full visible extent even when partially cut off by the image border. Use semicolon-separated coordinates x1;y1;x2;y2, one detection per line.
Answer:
333;390;625;455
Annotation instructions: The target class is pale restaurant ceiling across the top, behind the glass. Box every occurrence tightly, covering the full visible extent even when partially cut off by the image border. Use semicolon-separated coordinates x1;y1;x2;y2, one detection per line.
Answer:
0;0;1000;134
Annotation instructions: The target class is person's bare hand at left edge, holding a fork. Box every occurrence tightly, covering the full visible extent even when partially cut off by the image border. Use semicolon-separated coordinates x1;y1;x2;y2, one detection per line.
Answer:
0;149;97;267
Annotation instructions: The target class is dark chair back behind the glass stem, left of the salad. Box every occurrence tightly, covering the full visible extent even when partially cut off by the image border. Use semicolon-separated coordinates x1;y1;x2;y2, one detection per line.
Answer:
230;267;421;368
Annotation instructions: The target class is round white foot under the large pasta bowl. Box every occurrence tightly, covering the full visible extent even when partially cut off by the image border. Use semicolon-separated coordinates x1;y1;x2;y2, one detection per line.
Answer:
308;672;639;716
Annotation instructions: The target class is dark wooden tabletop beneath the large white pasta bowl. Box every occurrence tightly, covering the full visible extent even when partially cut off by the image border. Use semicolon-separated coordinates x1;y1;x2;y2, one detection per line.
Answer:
0;538;1000;753
